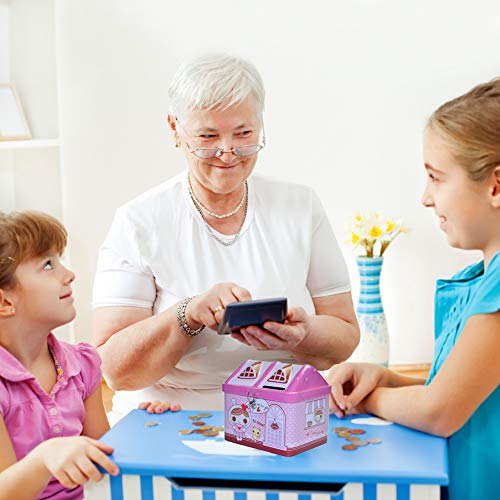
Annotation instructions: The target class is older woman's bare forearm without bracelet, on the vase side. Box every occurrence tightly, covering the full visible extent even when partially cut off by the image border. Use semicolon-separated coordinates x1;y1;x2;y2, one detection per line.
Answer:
292;314;359;370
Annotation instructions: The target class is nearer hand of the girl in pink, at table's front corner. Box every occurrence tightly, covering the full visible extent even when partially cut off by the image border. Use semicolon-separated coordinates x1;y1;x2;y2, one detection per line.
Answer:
33;436;120;490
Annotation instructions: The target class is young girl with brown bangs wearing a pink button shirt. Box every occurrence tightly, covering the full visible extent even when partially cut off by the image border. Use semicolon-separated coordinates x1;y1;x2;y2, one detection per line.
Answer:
0;212;178;500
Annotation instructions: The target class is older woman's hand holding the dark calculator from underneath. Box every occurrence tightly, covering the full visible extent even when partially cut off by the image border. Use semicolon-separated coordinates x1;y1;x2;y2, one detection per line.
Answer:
231;307;311;351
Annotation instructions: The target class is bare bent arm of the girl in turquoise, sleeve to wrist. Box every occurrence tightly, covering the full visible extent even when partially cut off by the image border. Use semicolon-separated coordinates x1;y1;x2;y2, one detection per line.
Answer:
363;311;500;437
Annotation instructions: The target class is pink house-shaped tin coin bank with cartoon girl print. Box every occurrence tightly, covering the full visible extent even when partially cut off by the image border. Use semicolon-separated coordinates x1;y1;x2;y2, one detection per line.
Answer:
222;360;330;457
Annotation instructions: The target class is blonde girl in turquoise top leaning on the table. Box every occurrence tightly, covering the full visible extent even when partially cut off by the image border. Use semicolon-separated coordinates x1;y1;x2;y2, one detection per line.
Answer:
329;79;500;500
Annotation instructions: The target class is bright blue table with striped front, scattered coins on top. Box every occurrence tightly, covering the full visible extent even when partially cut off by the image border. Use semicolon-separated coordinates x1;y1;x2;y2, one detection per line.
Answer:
101;410;448;500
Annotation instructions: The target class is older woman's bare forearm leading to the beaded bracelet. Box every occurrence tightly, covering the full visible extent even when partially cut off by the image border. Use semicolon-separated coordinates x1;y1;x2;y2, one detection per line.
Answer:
98;306;192;390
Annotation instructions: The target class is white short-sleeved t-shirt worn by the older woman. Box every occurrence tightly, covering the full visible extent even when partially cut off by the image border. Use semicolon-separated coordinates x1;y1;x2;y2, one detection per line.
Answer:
93;172;351;413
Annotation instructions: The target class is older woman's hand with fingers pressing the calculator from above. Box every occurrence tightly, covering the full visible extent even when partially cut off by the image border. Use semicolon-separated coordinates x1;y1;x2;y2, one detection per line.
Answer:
186;283;252;330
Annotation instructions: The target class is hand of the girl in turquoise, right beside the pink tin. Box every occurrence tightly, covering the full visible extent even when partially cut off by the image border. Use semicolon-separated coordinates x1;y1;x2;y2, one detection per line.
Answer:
327;363;385;418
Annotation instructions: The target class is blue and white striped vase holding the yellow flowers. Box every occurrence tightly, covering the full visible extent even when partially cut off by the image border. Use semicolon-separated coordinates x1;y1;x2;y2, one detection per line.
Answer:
351;257;389;366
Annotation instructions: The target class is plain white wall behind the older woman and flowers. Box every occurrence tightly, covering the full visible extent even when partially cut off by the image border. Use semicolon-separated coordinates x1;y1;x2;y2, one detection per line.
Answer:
56;0;500;363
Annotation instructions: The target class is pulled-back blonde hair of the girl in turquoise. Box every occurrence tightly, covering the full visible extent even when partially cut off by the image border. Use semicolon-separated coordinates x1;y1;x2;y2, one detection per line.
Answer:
427;78;500;182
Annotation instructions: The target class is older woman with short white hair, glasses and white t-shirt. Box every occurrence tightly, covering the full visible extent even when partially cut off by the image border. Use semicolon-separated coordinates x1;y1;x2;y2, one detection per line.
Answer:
93;56;359;415
